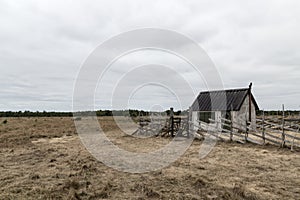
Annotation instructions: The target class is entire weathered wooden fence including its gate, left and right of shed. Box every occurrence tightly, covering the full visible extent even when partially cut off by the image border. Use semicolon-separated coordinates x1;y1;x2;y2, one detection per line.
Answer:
133;108;300;149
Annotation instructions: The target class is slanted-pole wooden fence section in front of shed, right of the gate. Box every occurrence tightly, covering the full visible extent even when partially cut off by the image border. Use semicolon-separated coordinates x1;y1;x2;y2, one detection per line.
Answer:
190;116;300;149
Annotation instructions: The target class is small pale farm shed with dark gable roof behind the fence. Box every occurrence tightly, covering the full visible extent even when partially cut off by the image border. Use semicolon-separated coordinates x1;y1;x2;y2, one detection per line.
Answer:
191;83;259;130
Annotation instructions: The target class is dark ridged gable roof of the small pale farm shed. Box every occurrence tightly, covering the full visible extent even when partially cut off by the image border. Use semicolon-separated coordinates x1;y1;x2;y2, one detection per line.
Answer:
192;88;259;111
